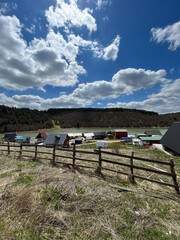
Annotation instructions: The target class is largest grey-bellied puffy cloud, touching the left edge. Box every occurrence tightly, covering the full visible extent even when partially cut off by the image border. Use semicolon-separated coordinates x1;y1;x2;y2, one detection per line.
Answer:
0;15;86;91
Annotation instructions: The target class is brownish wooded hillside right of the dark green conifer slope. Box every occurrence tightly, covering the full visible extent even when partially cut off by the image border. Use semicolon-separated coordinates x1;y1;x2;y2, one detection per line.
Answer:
47;108;180;128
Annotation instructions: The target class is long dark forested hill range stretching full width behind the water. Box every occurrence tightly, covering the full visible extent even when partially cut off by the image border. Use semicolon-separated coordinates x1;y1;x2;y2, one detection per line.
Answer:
0;105;180;133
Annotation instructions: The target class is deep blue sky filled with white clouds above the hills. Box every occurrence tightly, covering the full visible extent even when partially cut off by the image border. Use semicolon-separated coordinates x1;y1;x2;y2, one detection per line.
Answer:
0;0;180;114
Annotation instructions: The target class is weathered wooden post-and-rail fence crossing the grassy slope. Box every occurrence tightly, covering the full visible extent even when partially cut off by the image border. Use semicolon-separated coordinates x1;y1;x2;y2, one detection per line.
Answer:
0;142;180;194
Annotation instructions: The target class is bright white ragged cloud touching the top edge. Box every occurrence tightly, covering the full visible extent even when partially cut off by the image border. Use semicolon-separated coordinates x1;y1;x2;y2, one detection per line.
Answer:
45;0;97;33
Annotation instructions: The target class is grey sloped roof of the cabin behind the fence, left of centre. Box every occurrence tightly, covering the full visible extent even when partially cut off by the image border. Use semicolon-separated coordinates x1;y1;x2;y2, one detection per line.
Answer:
44;133;68;145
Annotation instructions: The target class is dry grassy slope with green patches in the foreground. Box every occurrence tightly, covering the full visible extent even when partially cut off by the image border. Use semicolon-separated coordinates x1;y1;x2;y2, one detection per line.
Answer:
0;144;180;240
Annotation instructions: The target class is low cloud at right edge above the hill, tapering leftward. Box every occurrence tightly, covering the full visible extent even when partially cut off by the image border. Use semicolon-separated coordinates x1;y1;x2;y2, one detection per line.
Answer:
107;79;180;113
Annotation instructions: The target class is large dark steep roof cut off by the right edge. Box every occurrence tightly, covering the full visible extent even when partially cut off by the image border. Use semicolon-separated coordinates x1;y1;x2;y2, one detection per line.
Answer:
161;122;180;154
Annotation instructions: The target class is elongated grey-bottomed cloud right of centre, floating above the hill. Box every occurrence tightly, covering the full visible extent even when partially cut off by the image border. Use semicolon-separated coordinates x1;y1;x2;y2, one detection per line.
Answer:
73;68;166;100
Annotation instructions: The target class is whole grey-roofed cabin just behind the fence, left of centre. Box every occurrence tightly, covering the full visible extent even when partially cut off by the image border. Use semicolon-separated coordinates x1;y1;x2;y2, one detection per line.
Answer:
43;133;70;147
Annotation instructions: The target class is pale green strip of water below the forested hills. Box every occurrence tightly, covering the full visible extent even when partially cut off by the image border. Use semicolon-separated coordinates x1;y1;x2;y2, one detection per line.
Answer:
0;127;168;138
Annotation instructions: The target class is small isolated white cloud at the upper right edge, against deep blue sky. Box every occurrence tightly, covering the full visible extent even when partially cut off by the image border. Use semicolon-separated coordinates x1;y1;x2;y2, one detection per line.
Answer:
151;21;180;50
